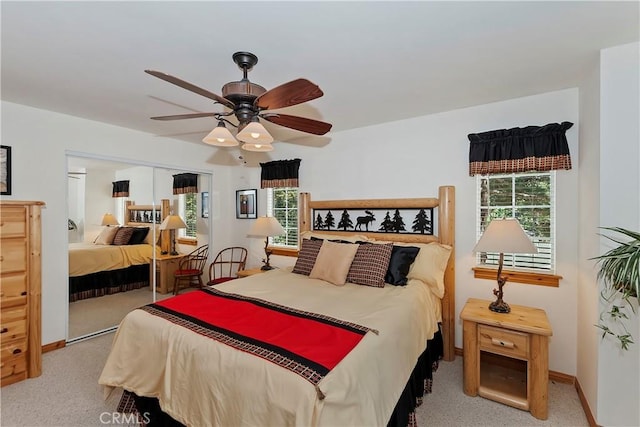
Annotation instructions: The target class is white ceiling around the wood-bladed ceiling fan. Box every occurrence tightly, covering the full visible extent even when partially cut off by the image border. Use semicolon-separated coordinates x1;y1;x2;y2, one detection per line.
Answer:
1;0;640;147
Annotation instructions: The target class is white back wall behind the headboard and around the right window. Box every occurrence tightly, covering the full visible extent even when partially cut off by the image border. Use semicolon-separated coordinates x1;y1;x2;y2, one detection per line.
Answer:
236;89;579;375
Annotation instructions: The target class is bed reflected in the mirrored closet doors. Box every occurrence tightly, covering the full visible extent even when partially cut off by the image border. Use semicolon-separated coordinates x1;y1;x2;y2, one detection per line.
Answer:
69;199;169;302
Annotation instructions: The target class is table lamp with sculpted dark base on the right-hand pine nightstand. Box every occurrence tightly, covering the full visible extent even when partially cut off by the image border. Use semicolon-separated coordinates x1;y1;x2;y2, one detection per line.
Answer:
473;218;538;313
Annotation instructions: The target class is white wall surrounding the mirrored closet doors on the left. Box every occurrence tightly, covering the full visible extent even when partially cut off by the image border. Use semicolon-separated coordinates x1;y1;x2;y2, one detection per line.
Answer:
2;101;235;344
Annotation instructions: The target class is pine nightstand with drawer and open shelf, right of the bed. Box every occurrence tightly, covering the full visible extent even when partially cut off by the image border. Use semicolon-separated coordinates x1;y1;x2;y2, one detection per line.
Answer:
460;298;552;420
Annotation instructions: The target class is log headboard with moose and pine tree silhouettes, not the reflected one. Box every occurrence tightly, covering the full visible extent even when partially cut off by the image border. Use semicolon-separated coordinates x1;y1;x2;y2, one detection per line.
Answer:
299;186;455;361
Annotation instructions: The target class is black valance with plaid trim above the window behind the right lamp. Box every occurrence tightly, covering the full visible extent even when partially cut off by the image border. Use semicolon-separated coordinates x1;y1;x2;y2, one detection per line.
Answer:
469;122;573;176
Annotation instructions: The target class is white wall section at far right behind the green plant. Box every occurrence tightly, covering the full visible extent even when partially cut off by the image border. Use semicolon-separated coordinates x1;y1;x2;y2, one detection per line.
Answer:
597;43;640;426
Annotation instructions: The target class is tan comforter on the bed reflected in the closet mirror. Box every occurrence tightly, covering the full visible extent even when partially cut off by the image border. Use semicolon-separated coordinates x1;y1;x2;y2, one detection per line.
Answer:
69;243;153;277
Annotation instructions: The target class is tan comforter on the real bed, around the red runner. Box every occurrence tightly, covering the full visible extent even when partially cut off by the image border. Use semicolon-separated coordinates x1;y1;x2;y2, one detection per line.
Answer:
99;268;440;426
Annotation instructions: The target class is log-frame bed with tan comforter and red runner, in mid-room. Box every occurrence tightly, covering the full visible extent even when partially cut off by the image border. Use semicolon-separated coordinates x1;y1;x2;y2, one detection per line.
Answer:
99;187;455;426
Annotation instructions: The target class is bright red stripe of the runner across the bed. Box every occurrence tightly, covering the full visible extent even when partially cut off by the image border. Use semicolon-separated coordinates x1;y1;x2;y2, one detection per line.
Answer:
152;290;368;370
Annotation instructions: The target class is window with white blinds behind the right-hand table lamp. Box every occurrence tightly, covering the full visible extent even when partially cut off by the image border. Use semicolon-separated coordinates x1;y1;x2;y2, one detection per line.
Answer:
476;172;555;273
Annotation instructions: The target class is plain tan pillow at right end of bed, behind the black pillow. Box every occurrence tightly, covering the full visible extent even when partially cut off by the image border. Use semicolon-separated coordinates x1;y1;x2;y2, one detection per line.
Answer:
407;242;451;298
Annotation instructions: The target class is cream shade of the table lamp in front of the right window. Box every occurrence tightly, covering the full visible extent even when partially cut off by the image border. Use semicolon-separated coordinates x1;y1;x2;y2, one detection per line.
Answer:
473;218;538;254
